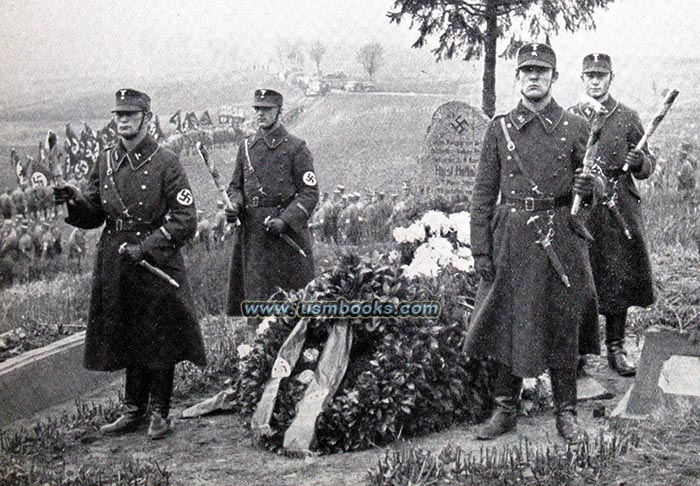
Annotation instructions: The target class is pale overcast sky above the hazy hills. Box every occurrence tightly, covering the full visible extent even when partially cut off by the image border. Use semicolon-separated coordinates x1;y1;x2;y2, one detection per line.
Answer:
0;0;700;85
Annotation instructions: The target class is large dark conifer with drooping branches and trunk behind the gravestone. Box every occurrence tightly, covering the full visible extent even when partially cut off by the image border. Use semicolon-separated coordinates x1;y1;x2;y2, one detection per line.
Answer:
387;0;614;116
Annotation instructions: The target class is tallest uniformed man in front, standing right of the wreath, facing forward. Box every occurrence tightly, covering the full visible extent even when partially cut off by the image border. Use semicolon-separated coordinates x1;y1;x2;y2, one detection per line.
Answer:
464;44;604;441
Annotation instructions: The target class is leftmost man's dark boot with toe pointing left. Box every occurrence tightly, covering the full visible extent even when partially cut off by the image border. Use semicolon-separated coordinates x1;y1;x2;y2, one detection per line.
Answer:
100;366;151;434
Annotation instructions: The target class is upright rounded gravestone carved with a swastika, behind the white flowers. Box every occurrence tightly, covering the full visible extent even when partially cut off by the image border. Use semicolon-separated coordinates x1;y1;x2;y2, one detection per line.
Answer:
418;101;488;201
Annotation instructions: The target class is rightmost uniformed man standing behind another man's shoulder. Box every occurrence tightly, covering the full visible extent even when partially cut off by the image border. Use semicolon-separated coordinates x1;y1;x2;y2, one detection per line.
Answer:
570;53;656;376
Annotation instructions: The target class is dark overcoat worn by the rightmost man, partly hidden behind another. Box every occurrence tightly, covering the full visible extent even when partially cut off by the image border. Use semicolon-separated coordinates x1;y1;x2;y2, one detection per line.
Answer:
570;97;656;314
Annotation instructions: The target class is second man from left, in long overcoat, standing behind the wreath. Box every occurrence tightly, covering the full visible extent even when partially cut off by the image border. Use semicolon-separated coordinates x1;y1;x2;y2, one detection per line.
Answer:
226;89;319;315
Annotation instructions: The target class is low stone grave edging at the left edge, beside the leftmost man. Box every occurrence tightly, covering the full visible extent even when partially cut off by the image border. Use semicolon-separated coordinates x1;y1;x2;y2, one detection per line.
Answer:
0;332;121;426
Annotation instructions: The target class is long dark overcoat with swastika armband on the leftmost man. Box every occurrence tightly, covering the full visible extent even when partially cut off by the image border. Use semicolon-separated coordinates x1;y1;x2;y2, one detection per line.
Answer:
66;135;206;371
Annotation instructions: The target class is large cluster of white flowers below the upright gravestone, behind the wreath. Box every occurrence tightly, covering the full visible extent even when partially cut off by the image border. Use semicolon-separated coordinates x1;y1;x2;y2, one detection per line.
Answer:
393;210;474;278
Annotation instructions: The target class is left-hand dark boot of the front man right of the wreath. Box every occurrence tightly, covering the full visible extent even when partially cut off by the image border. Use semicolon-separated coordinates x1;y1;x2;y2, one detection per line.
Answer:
475;363;523;440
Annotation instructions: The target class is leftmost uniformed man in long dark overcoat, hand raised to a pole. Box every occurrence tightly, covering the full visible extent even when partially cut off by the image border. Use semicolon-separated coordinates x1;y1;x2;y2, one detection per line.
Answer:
54;89;206;439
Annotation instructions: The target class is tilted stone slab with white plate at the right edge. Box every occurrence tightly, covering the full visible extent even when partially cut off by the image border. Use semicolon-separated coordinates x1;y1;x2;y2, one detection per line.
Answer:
627;330;700;415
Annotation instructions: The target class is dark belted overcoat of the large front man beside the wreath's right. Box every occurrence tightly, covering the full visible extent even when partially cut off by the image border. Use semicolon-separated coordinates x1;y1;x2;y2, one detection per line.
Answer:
464;100;602;377
